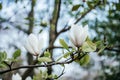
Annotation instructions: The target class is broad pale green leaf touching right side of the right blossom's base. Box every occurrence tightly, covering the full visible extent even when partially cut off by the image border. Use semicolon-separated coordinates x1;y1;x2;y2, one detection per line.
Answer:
82;40;96;52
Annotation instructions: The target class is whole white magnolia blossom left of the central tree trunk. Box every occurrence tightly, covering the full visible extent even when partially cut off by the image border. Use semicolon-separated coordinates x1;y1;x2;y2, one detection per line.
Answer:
25;33;43;56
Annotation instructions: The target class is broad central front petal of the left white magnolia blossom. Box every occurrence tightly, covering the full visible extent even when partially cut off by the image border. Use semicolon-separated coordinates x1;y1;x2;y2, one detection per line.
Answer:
28;34;39;54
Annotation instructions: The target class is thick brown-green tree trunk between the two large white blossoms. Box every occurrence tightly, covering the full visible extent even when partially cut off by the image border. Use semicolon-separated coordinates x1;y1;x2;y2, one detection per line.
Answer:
47;0;61;80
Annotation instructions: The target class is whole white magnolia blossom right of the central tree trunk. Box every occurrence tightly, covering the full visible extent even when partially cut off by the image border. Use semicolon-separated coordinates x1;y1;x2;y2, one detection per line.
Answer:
69;25;88;47
